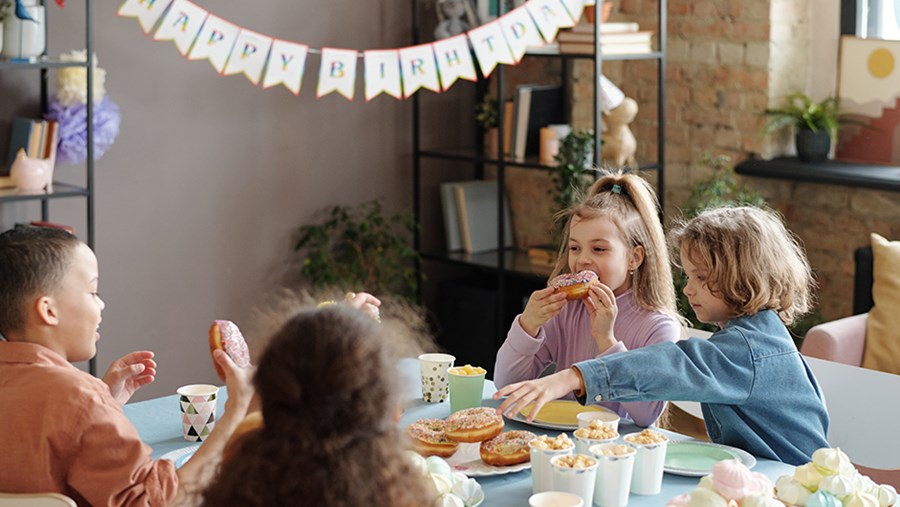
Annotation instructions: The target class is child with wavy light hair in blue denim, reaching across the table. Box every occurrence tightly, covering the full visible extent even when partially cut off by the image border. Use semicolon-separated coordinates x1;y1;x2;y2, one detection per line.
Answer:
495;207;828;465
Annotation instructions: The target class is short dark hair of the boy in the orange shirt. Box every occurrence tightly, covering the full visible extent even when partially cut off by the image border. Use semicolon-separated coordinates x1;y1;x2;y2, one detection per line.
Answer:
0;227;81;333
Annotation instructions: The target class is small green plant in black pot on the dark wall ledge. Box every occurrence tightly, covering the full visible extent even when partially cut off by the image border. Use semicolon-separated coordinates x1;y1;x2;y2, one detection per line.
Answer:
765;92;842;162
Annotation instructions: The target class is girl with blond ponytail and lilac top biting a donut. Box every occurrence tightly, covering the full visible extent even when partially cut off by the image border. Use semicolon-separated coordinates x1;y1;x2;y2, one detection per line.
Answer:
494;173;681;426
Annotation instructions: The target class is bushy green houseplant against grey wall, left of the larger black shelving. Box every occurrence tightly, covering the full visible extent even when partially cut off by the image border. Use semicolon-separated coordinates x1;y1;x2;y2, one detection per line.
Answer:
294;199;421;300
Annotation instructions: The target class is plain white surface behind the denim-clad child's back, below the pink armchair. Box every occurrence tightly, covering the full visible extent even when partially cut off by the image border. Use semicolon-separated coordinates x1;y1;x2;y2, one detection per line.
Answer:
804;356;900;483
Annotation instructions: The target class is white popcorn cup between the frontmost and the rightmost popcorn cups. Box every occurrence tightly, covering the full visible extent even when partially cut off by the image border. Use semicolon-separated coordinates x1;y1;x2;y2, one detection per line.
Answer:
591;443;637;507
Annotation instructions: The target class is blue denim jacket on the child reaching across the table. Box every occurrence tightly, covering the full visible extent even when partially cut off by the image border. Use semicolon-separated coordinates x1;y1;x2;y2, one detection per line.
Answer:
575;310;829;465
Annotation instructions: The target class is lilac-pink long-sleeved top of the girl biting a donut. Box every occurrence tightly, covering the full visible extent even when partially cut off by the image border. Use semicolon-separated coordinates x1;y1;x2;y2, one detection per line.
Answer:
494;290;681;426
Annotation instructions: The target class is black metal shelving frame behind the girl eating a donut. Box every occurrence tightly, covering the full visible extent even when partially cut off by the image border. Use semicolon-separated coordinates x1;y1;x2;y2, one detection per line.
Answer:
412;0;666;366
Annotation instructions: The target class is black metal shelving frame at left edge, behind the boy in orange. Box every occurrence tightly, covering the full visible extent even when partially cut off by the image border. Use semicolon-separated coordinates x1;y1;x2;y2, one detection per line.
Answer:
0;0;97;375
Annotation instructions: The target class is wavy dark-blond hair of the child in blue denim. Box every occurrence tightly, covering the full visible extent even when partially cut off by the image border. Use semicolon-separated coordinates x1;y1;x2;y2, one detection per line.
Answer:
670;206;815;325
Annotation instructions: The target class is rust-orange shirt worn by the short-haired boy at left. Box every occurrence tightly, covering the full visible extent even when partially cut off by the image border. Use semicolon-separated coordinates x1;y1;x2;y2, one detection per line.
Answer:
0;340;178;506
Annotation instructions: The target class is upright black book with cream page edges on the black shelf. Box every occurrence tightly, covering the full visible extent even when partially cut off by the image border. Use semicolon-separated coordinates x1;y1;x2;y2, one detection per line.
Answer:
511;84;566;160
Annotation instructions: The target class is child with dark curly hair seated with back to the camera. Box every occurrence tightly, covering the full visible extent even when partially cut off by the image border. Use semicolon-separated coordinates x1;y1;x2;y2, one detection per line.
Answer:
203;300;433;507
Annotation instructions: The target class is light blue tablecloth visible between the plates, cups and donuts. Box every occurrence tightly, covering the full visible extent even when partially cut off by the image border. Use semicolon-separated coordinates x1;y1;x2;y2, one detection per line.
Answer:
125;367;794;507
